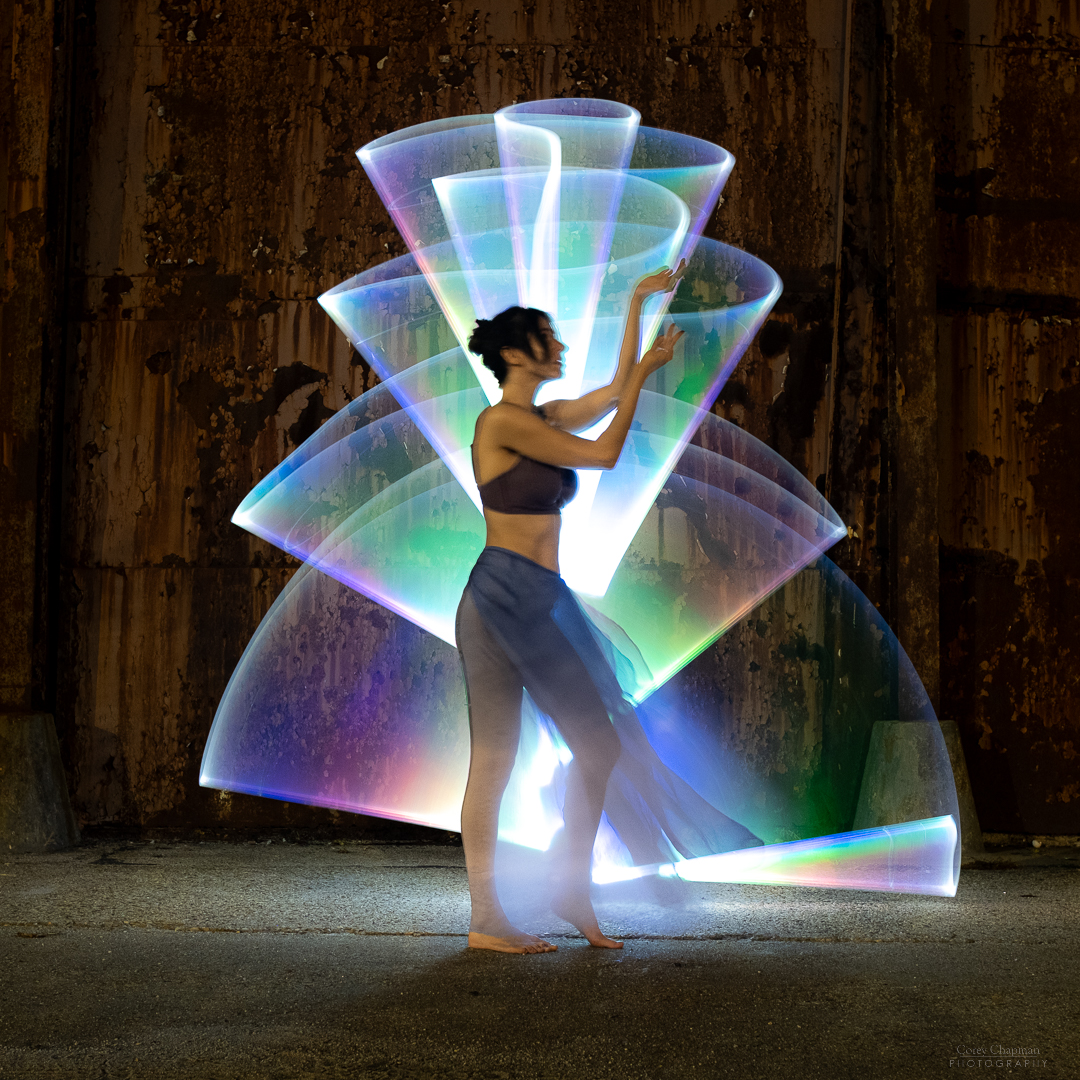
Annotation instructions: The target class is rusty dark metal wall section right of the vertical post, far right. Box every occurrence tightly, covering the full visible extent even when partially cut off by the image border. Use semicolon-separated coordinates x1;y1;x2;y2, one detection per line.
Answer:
934;0;1080;834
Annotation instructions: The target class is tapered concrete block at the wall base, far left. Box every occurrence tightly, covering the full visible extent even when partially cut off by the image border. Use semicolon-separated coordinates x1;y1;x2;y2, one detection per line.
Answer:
0;713;79;853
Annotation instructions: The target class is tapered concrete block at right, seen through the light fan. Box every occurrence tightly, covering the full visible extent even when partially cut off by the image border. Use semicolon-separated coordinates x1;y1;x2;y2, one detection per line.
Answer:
852;720;983;859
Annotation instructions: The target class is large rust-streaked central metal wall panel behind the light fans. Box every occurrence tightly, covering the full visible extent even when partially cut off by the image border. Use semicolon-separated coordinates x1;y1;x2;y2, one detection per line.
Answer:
56;0;842;825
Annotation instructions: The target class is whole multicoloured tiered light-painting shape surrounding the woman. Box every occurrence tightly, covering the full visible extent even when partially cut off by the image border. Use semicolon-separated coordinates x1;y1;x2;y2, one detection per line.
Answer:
201;98;959;895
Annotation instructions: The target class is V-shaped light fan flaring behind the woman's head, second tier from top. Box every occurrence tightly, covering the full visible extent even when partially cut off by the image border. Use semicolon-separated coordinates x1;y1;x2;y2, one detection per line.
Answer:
320;234;780;596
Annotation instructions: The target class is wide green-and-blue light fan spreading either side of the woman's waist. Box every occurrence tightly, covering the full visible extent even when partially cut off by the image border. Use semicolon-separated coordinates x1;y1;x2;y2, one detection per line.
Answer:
225;356;843;686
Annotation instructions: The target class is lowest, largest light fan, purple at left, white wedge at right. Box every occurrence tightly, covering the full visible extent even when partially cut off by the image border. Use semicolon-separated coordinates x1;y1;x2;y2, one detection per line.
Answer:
201;531;959;894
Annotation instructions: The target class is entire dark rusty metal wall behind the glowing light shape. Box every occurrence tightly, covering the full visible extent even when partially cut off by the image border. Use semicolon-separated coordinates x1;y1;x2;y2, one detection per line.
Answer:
0;0;1080;836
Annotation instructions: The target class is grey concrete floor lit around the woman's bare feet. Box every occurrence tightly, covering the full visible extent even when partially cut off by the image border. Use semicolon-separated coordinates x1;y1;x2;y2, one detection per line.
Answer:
0;841;1080;1080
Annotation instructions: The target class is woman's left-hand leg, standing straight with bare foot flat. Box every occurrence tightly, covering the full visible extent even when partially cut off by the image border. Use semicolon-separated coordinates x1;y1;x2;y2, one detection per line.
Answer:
457;589;555;953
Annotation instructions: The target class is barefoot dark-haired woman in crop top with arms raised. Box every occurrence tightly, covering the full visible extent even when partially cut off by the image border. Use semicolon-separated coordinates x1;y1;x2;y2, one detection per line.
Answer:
457;265;684;953
